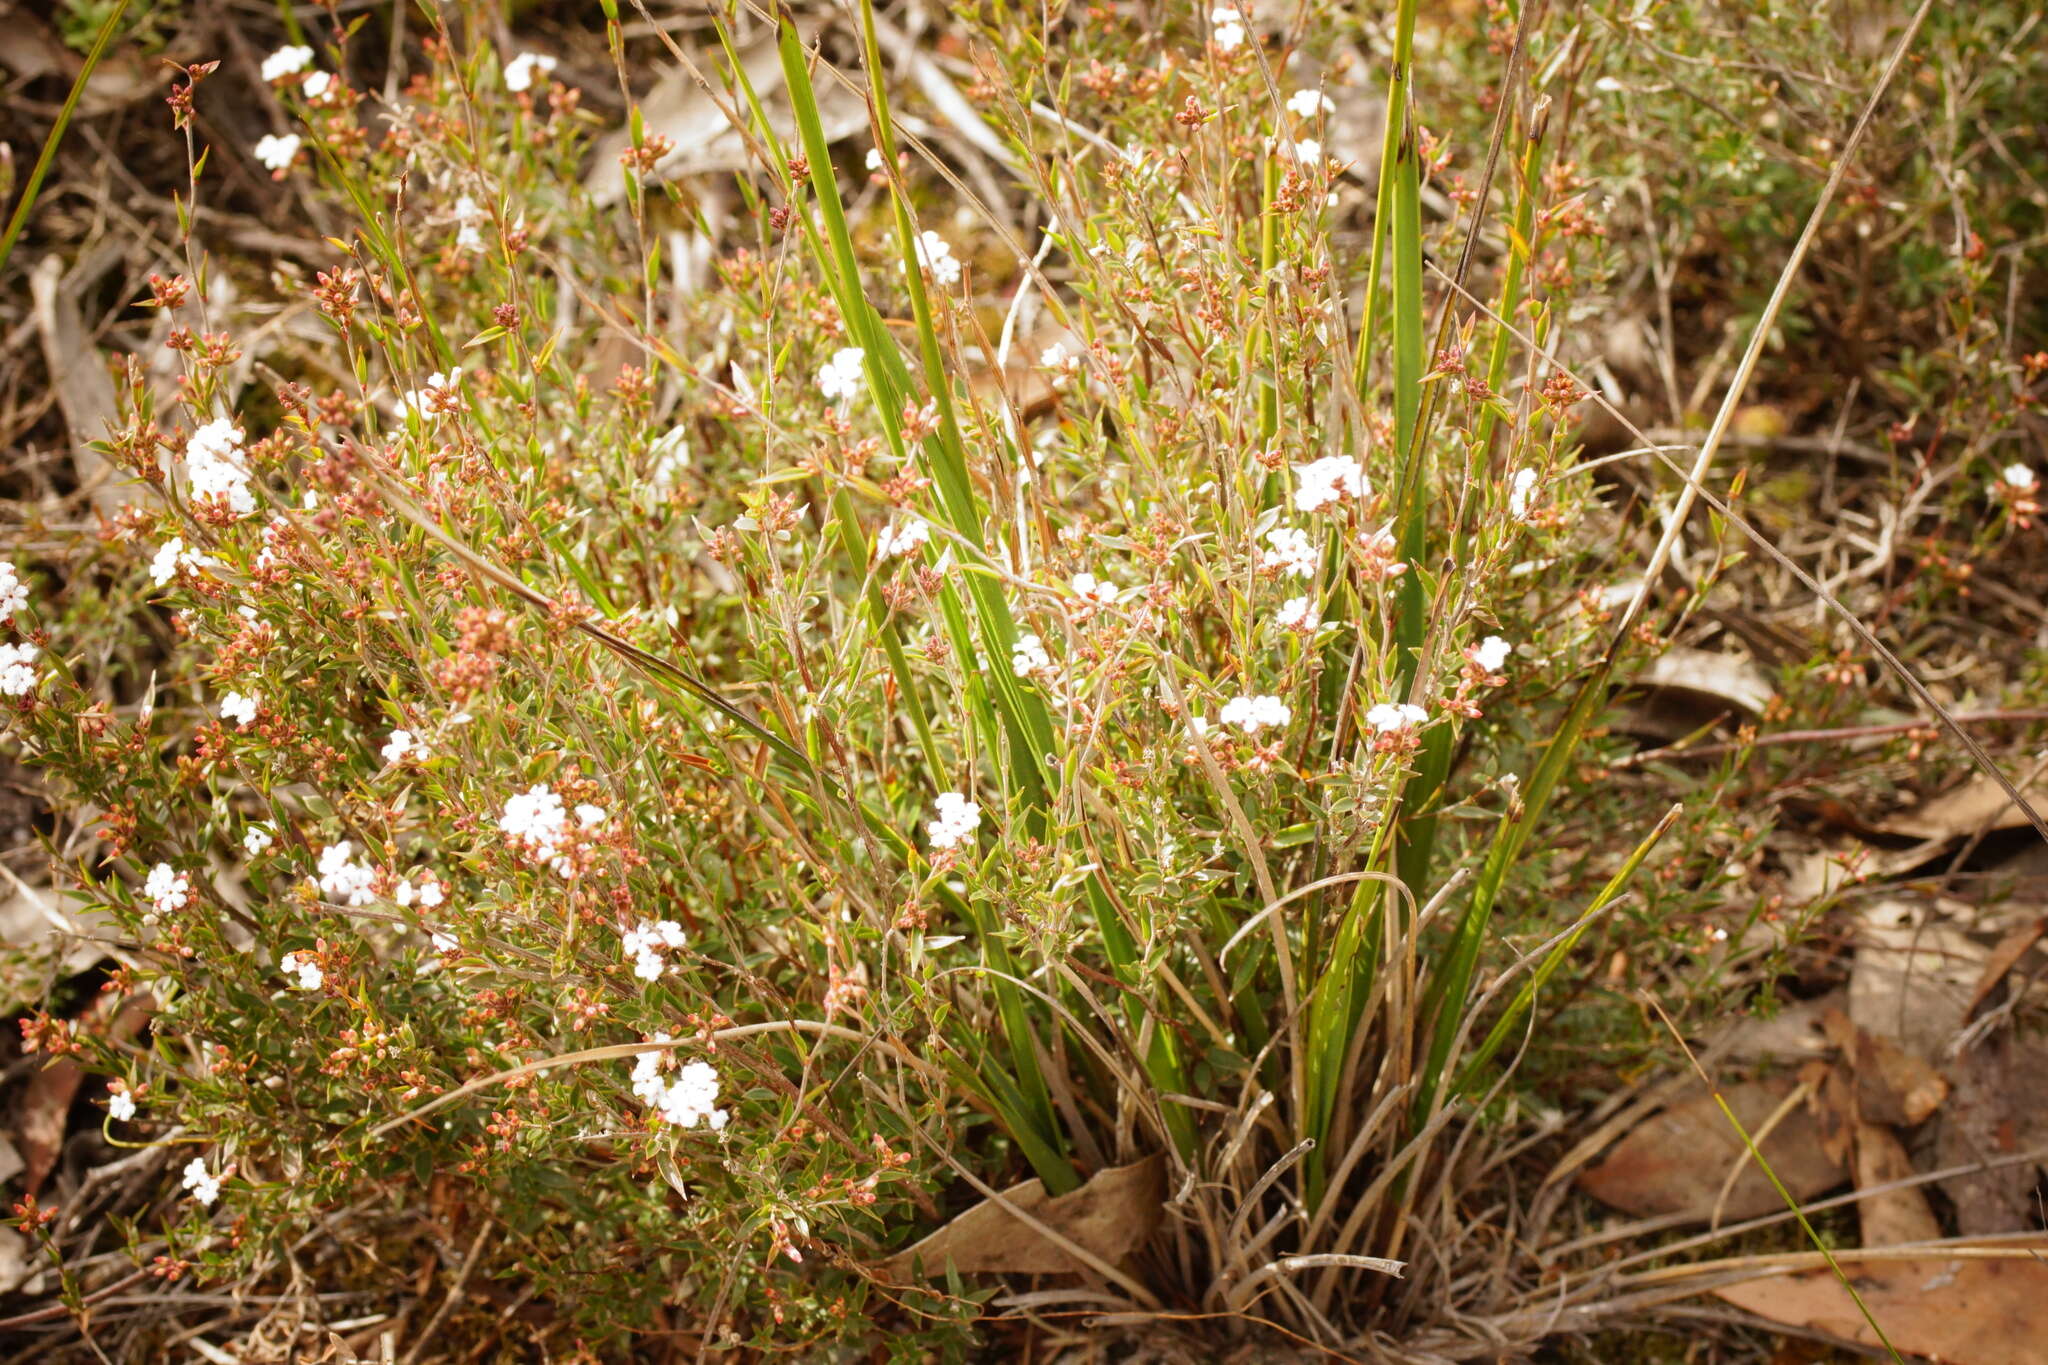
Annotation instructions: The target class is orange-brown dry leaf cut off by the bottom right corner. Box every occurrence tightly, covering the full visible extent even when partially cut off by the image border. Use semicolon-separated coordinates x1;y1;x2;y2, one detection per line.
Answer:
1714;1242;2048;1365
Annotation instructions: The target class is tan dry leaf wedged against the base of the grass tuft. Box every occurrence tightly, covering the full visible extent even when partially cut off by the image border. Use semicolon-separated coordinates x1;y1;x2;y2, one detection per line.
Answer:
881;1154;1165;1277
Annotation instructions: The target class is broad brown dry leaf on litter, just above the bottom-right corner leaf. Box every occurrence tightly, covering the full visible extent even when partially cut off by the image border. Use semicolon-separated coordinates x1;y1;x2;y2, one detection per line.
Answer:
1579;1076;1845;1222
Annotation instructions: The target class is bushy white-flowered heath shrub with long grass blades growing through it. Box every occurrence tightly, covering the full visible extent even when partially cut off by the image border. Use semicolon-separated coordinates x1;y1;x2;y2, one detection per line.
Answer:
0;0;2036;1353
